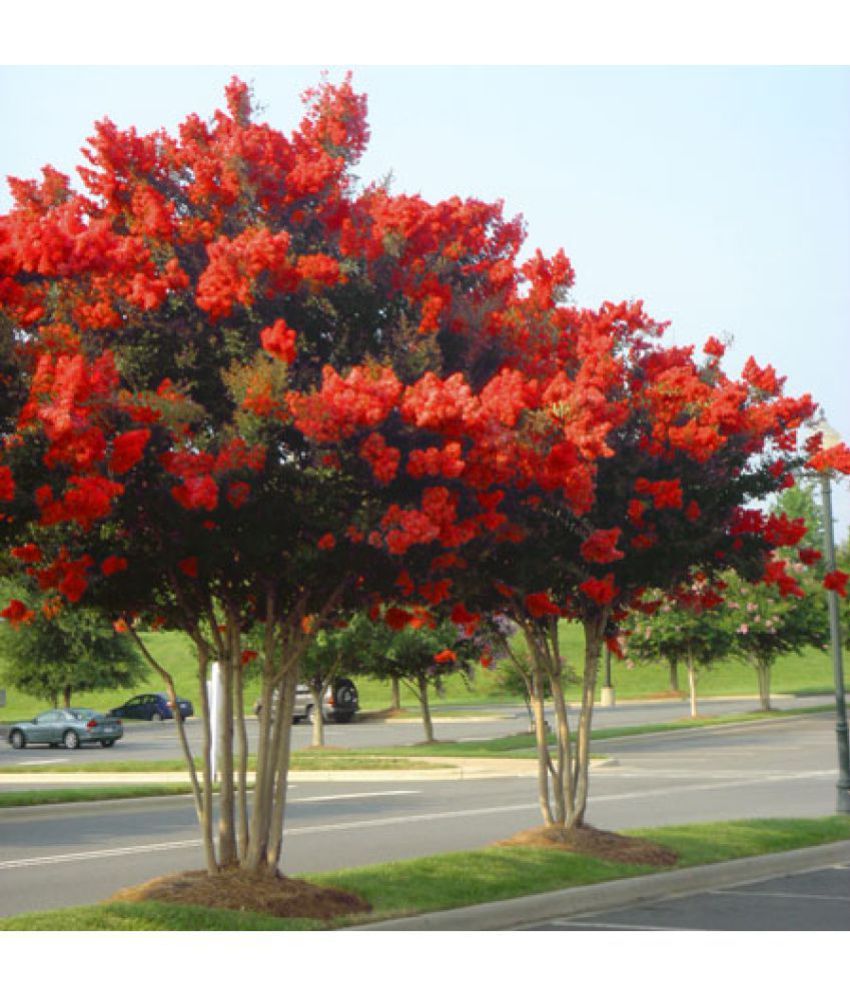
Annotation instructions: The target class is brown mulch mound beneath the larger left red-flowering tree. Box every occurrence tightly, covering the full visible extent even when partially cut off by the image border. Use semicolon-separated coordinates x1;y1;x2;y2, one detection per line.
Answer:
109;868;372;920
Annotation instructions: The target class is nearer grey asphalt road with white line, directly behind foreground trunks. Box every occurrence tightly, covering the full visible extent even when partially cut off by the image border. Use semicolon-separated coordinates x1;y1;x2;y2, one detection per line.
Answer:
0;714;836;915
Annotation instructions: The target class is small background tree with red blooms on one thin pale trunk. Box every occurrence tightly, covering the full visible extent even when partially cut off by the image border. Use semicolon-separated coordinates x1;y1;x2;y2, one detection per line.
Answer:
623;579;735;719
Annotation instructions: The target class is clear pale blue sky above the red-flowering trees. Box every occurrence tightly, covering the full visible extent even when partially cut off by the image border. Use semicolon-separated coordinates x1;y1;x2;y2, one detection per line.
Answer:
0;66;850;536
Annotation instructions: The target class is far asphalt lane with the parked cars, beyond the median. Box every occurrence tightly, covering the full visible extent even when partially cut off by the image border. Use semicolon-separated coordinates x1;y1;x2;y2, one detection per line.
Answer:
0;696;831;772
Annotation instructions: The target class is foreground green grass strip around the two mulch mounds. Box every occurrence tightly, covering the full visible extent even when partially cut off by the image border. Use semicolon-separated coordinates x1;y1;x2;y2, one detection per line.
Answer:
0;816;850;931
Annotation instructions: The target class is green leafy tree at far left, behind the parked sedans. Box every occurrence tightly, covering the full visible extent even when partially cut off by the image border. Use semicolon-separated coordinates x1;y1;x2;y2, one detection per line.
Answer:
0;591;147;708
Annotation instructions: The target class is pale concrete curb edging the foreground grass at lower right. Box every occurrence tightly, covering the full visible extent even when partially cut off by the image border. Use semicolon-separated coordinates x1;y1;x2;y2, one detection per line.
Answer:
346;840;850;931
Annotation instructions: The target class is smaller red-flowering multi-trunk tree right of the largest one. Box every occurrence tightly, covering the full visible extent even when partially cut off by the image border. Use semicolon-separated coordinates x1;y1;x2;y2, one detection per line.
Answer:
438;320;814;830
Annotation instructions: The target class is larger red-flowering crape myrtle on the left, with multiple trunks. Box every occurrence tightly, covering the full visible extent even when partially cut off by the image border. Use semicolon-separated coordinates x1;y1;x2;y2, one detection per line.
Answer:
0;80;607;873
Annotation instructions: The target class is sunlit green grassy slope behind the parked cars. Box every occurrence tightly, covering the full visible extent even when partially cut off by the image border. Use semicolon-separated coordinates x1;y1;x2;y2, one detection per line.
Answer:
0;622;833;724
